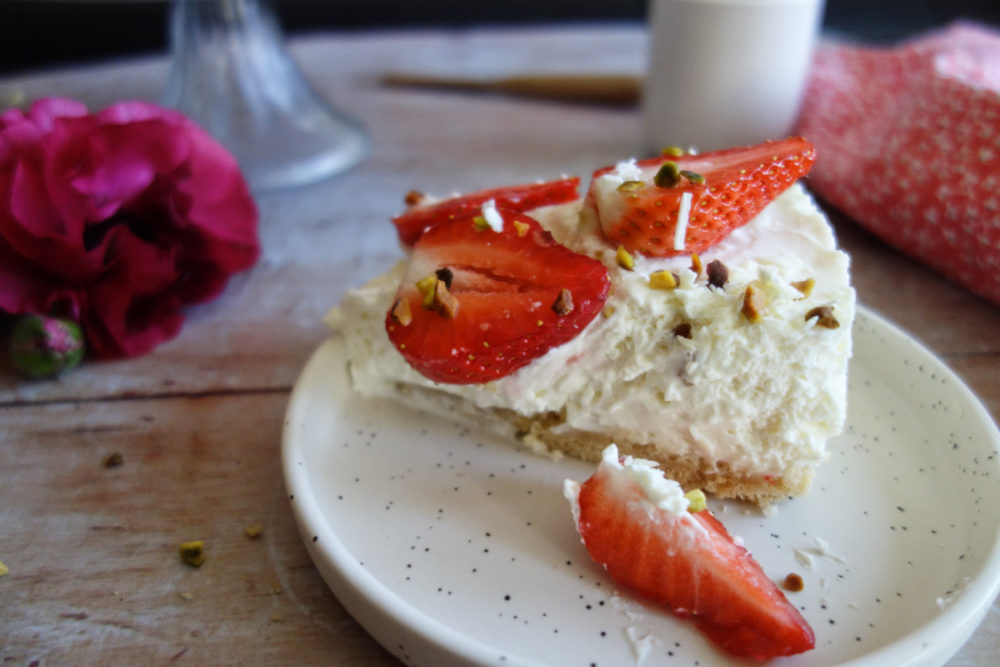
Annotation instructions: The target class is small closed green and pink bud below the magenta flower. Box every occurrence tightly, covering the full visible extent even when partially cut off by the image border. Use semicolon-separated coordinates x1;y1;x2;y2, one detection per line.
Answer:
10;315;83;378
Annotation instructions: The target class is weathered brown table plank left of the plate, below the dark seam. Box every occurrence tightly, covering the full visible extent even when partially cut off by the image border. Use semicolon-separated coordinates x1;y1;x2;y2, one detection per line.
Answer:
0;392;398;665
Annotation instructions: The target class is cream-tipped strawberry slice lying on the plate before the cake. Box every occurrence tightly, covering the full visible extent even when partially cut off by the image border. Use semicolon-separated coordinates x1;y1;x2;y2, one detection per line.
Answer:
566;445;815;660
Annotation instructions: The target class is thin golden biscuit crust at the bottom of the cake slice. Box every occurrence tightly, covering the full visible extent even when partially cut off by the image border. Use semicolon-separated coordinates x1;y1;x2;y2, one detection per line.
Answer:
395;383;814;507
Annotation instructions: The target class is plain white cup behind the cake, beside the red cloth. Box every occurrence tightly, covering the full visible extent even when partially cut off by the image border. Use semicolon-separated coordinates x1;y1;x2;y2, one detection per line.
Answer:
642;0;823;152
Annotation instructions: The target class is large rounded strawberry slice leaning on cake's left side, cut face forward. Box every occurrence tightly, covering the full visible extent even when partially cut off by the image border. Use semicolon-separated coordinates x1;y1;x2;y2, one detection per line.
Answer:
385;207;610;384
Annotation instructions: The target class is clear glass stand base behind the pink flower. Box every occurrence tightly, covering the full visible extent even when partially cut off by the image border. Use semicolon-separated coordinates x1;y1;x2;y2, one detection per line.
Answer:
163;0;368;191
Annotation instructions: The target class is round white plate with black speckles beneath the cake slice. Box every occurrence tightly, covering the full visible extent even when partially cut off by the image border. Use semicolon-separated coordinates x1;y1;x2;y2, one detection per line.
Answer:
283;310;1000;666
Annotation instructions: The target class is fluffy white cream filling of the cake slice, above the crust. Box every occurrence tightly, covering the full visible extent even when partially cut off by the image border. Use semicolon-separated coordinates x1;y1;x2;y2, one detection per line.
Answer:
329;185;855;476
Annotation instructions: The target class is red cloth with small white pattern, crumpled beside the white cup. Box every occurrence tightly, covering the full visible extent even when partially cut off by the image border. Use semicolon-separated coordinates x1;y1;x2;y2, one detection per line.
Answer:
796;23;1000;303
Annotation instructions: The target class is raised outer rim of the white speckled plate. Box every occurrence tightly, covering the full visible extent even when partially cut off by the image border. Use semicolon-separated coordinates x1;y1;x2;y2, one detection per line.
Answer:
281;303;1000;667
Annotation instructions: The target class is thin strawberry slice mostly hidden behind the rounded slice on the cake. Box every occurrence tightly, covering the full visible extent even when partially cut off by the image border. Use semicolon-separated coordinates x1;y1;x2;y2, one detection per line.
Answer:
392;177;580;246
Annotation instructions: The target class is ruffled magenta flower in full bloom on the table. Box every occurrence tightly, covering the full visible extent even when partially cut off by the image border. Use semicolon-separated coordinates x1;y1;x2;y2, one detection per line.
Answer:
0;99;260;358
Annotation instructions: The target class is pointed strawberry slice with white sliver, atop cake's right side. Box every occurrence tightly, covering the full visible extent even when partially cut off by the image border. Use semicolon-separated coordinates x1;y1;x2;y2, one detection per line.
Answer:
587;137;815;257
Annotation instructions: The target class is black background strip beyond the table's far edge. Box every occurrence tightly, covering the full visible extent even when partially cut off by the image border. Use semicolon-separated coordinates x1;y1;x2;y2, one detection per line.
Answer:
0;0;1000;73
